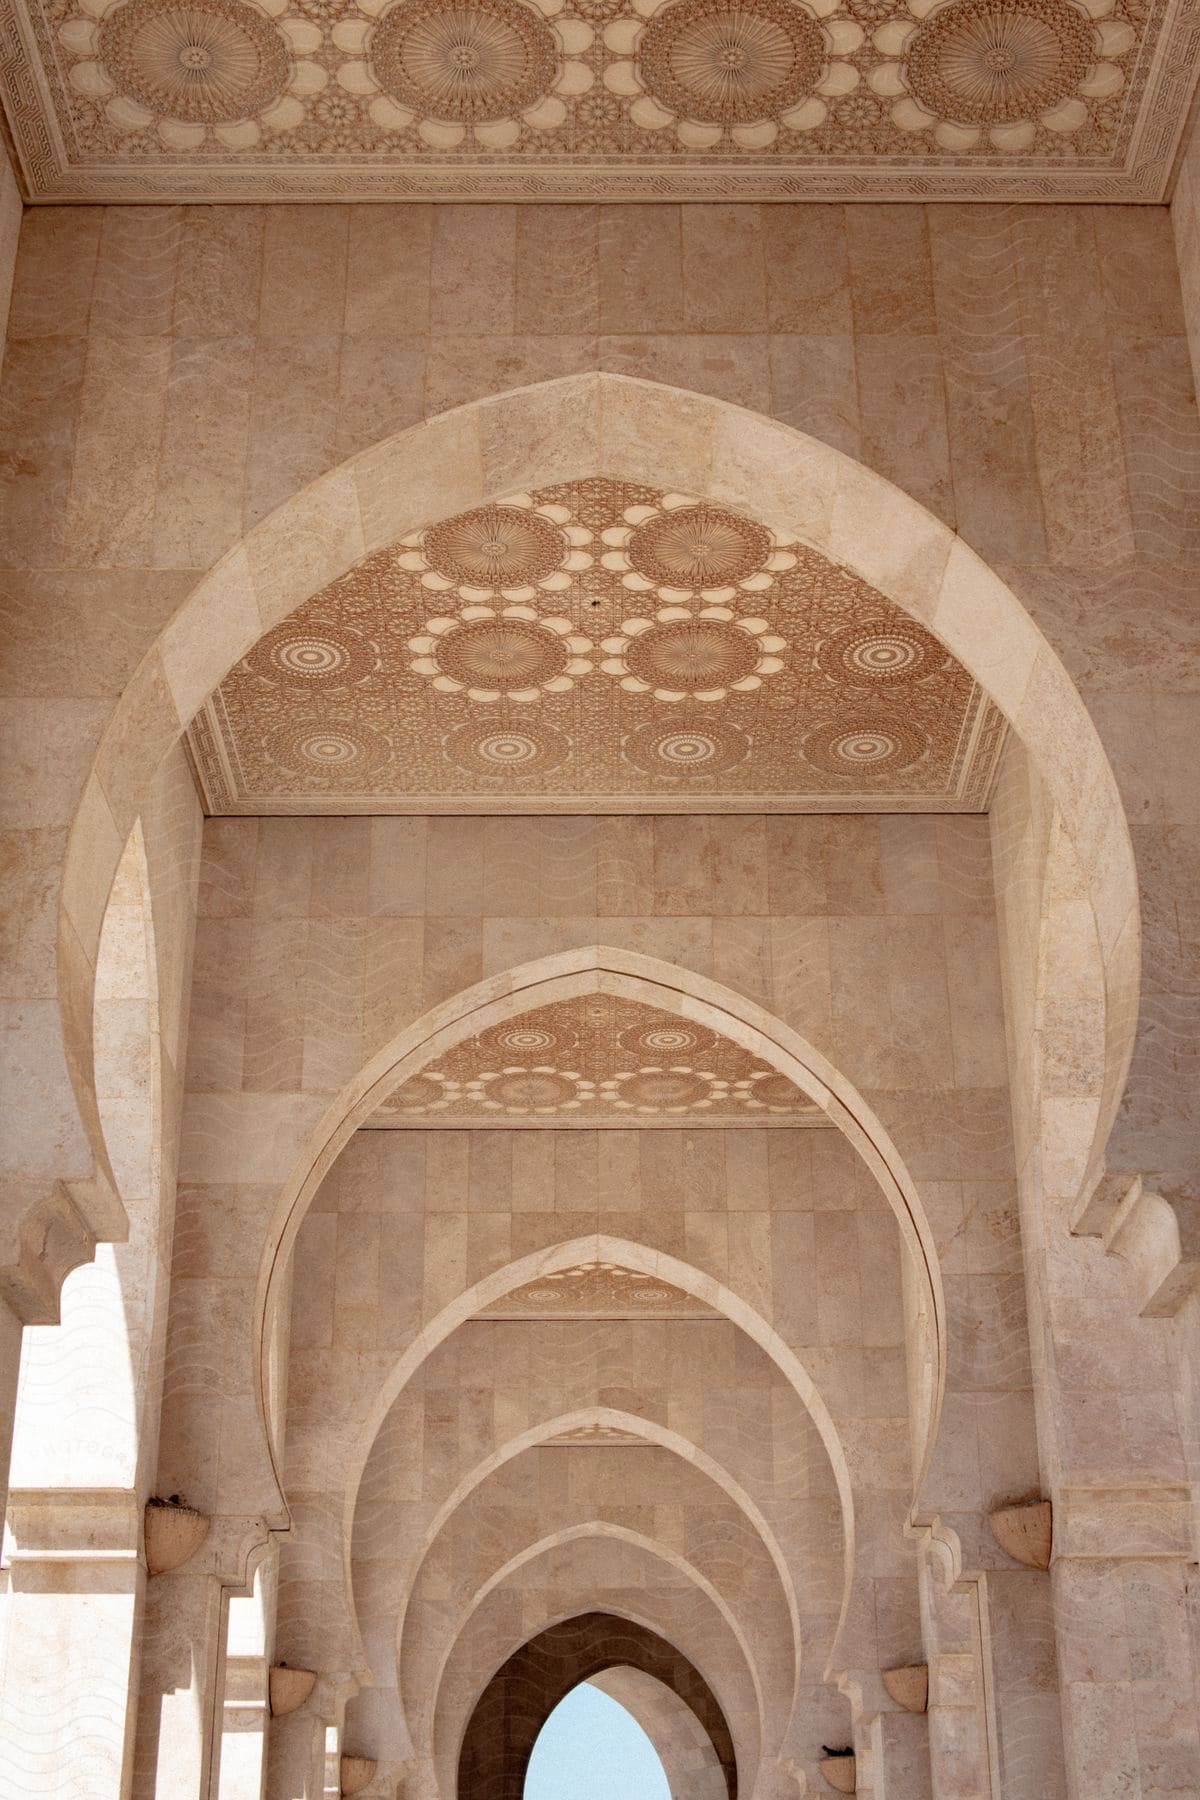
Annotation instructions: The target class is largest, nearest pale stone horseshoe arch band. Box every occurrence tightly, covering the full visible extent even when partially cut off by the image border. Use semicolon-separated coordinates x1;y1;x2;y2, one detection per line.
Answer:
59;373;1139;1296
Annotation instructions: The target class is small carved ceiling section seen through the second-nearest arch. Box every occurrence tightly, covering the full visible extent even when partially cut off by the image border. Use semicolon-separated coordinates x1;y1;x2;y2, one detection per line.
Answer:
361;994;828;1127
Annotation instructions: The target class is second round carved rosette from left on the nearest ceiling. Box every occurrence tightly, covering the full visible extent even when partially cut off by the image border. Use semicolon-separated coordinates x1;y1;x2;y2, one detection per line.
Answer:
371;0;558;124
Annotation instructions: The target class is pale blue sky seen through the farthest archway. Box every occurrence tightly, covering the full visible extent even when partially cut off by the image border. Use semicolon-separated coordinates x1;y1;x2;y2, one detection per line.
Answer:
525;1681;671;1800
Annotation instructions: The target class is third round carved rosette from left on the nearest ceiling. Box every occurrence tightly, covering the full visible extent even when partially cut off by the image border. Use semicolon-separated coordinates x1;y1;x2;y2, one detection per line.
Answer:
637;0;826;124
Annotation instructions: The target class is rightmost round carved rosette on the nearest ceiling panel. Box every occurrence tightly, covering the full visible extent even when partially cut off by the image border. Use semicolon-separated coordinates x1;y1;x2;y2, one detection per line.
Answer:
905;0;1096;126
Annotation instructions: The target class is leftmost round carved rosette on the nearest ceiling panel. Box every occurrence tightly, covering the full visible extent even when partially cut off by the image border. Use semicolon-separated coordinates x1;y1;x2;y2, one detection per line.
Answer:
99;0;291;124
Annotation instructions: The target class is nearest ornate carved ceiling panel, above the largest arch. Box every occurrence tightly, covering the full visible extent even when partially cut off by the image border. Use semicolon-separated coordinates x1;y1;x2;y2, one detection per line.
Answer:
0;0;1200;200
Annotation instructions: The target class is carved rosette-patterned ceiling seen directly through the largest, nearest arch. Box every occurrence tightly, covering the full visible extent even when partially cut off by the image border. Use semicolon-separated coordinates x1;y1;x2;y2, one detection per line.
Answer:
191;477;1004;814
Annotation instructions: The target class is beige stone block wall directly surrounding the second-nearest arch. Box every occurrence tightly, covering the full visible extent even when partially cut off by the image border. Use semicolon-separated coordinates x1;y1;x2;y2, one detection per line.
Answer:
162;817;1034;1510
